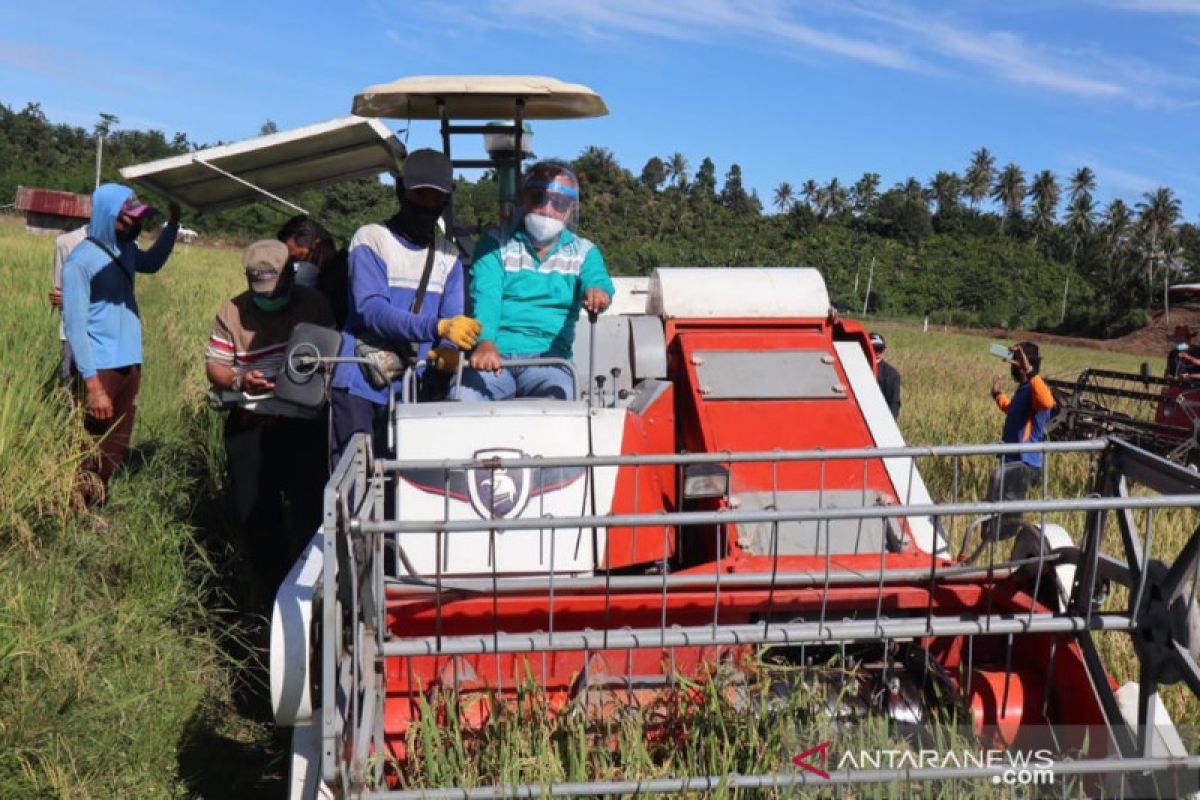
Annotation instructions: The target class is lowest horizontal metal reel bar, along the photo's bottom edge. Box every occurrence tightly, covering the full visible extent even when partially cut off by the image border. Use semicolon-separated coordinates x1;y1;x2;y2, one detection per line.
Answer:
364;756;1200;800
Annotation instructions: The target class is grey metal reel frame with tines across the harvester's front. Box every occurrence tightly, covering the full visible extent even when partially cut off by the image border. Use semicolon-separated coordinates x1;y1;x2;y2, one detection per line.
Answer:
322;440;1200;798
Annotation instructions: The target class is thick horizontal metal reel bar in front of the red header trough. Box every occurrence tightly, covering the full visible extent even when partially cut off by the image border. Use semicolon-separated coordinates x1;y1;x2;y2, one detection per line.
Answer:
379;613;1136;657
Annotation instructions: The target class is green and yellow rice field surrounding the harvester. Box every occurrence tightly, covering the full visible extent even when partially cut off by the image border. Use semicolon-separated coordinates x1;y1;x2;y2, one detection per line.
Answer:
0;218;1200;798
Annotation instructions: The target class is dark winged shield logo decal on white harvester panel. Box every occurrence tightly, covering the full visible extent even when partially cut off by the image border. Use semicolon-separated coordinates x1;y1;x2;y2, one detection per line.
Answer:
400;447;584;519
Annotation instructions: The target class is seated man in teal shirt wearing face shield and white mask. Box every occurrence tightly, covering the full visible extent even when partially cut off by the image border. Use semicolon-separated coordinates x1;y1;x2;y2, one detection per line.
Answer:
462;161;613;401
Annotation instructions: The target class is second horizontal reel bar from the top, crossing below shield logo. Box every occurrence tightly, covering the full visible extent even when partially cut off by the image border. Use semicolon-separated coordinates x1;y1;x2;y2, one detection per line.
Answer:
350;494;1200;534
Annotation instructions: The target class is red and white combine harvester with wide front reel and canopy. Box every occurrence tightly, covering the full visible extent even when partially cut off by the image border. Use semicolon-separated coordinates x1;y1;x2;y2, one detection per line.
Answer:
271;78;1200;798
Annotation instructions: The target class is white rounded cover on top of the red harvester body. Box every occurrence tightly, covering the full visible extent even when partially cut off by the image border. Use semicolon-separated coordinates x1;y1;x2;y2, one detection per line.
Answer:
647;266;829;319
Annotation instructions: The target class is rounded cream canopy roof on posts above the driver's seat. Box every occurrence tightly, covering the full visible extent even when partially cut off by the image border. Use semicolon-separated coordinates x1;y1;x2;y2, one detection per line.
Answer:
350;76;608;120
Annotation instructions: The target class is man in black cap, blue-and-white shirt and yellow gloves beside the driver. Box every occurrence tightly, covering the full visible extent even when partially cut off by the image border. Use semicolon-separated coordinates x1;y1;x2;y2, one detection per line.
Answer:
330;149;479;464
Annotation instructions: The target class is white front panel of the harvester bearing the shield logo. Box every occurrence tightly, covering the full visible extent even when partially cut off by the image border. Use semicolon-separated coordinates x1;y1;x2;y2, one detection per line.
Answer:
396;401;625;577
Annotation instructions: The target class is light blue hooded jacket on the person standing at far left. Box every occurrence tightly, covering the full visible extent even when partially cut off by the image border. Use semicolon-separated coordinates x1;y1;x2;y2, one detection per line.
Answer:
62;184;179;380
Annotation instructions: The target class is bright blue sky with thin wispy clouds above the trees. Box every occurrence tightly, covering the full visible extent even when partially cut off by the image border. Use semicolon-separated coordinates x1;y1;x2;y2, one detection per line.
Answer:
0;0;1200;222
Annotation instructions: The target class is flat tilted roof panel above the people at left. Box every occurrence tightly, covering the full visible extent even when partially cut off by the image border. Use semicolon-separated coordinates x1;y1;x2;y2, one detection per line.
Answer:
121;116;404;212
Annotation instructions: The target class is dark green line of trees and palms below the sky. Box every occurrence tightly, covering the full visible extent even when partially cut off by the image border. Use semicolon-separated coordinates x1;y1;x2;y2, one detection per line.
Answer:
0;103;1200;336
